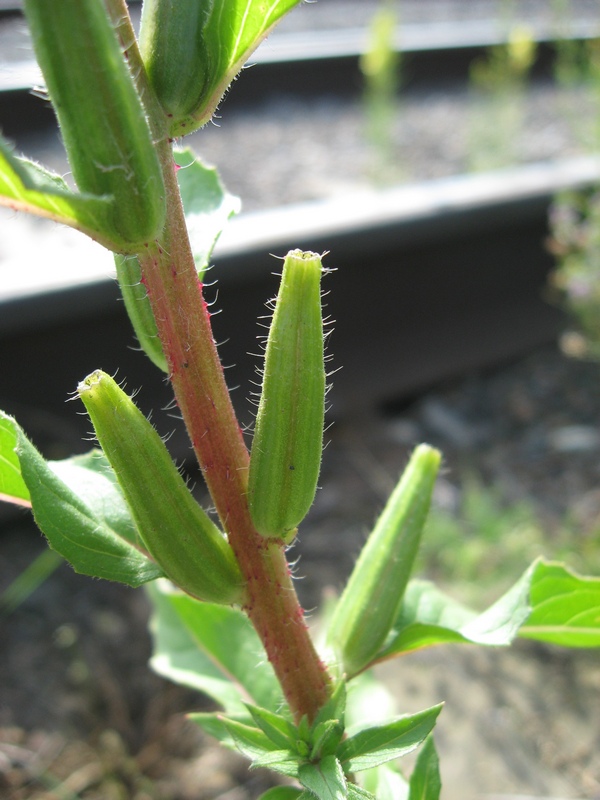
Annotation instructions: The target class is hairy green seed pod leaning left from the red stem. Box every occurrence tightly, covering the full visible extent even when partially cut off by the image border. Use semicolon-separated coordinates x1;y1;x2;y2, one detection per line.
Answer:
77;370;243;604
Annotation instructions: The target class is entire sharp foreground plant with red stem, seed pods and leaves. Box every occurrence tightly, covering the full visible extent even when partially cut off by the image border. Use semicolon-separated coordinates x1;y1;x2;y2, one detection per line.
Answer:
0;0;600;800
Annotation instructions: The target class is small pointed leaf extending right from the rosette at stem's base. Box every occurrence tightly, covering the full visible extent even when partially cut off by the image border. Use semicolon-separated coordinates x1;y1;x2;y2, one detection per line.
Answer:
338;705;442;772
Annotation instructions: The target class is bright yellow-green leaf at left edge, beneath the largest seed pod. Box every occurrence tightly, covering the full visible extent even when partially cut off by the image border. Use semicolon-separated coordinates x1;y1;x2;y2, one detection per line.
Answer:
0;136;114;249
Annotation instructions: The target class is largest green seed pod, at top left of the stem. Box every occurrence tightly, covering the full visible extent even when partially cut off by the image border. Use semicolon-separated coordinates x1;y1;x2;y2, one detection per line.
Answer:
25;0;165;251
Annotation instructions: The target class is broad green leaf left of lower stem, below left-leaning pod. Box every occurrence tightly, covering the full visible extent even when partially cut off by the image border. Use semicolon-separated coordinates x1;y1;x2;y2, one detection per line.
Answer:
148;581;283;719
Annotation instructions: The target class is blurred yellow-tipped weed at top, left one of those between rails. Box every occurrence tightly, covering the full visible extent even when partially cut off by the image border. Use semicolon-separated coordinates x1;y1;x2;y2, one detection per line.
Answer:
360;2;401;181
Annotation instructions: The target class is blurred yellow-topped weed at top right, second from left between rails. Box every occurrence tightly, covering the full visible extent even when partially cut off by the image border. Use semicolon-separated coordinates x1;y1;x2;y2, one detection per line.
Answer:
468;25;536;171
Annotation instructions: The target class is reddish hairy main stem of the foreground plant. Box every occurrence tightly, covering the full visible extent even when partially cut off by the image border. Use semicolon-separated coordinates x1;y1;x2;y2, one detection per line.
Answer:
139;143;331;720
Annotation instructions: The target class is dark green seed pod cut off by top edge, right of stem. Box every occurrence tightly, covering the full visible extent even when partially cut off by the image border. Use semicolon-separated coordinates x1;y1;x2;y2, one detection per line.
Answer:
140;0;214;126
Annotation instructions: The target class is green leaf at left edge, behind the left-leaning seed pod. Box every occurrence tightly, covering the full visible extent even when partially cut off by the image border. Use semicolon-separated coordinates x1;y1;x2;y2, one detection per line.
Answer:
1;415;162;586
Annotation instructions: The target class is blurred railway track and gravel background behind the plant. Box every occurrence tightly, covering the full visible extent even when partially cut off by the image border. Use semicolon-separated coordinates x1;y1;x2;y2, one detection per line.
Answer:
0;0;600;800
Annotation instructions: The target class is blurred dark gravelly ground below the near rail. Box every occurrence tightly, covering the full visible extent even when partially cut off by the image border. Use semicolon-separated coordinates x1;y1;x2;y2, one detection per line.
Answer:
0;347;600;800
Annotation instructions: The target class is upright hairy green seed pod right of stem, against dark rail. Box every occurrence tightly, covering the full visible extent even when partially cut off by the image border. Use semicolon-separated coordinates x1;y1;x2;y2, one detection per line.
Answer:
248;250;325;538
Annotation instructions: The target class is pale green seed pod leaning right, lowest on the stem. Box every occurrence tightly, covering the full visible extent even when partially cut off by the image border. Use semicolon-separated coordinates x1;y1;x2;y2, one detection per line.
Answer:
328;445;441;677
